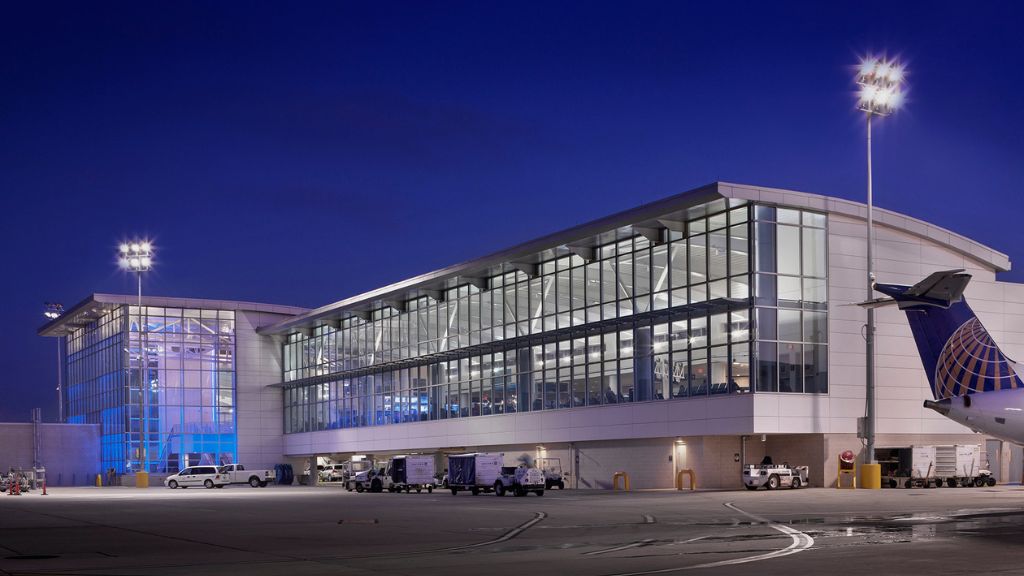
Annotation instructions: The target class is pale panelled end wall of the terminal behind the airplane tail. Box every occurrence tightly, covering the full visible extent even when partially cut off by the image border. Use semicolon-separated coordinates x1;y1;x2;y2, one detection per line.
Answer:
823;214;1024;434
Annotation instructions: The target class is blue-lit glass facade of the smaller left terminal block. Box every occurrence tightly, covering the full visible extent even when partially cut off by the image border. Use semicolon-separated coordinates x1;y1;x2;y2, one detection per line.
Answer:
63;305;238;474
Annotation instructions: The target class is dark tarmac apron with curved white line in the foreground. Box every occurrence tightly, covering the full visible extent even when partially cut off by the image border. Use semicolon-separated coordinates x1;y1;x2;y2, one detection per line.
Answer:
0;486;1024;576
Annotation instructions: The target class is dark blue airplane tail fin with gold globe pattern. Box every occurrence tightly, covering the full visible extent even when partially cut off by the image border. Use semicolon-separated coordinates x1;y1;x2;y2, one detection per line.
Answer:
865;270;1024;400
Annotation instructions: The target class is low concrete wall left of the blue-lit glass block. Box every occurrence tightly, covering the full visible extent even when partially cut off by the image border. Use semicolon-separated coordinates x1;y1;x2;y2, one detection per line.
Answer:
0;422;102;486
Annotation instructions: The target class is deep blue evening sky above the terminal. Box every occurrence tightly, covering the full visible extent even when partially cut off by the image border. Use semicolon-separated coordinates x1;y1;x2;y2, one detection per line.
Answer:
0;2;1024;421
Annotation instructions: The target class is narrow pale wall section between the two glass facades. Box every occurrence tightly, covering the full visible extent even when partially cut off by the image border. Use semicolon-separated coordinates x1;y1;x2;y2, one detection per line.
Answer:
234;311;288;468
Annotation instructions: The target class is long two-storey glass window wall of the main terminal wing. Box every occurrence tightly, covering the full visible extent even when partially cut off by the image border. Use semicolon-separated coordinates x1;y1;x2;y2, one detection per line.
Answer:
283;200;827;433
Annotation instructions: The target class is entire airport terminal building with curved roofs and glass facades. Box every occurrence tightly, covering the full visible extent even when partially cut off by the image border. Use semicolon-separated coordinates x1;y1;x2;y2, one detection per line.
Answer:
40;182;1024;488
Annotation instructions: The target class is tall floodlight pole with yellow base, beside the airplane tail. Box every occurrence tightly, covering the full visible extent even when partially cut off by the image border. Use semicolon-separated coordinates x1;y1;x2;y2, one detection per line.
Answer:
857;57;905;473
